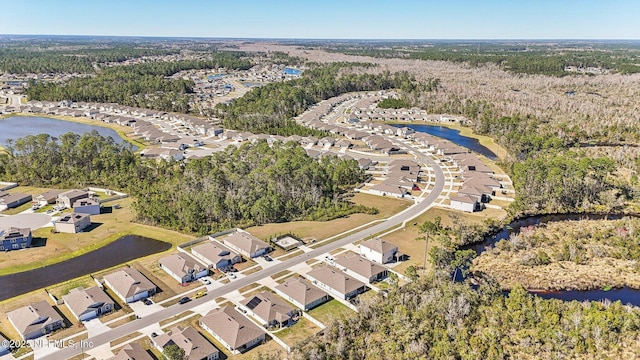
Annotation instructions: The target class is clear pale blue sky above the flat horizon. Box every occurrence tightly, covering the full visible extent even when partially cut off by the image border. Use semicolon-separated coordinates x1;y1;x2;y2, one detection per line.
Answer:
0;0;640;40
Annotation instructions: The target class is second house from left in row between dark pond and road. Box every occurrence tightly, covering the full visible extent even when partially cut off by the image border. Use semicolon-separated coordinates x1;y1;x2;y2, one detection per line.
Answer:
62;286;115;321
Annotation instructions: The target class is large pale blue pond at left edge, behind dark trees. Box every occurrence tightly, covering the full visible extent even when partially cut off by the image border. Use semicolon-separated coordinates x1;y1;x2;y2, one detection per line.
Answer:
0;116;135;150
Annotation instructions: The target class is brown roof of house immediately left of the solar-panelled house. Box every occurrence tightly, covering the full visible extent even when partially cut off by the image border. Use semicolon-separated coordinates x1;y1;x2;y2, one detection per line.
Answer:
200;306;264;349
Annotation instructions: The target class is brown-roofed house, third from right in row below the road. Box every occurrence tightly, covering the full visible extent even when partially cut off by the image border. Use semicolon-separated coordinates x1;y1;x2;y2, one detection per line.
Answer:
307;265;367;299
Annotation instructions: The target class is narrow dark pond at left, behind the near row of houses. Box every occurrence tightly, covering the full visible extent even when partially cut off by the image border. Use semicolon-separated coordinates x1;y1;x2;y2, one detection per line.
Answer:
0;235;171;301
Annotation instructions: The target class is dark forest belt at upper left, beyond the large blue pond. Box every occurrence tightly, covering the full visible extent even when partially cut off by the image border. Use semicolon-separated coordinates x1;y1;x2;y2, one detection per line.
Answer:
26;53;252;113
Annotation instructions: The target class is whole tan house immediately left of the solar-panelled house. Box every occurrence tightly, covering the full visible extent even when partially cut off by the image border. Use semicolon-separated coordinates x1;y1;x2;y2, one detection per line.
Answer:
198;306;265;354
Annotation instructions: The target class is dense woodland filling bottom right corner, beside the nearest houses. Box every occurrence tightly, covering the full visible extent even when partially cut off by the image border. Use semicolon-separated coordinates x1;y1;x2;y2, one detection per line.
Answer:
290;279;640;360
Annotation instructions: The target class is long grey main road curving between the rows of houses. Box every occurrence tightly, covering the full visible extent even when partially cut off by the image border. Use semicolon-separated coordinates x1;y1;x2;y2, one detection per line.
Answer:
41;124;445;360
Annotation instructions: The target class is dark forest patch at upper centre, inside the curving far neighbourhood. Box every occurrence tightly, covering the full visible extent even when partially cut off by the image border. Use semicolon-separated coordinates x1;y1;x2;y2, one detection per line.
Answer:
217;63;430;135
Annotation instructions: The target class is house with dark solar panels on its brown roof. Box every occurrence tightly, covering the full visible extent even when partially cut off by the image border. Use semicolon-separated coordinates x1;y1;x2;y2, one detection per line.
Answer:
238;291;298;327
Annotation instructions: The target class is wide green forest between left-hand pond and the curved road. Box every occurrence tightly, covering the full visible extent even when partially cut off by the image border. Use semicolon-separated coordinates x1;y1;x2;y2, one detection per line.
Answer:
0;133;376;234
